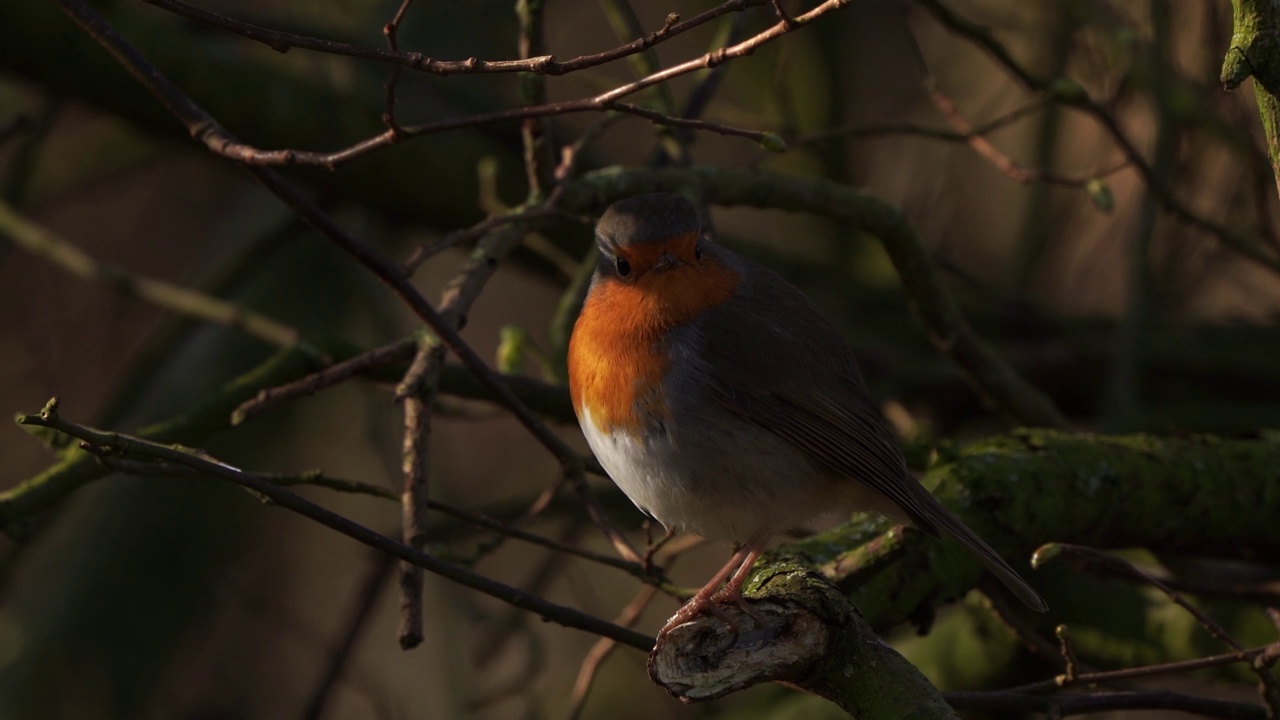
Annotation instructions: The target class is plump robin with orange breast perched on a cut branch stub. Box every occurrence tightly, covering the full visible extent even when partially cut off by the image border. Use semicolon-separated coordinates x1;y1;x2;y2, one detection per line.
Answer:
567;192;1048;637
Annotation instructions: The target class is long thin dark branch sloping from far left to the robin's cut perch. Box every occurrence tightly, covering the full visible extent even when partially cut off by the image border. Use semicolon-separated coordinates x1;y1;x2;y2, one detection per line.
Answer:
10;398;653;652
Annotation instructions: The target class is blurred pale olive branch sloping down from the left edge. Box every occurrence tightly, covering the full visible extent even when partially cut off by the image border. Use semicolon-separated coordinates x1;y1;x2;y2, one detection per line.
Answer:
0;200;307;356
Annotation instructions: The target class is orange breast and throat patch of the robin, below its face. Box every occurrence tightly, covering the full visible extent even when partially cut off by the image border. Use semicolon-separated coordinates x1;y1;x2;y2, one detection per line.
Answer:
568;258;737;432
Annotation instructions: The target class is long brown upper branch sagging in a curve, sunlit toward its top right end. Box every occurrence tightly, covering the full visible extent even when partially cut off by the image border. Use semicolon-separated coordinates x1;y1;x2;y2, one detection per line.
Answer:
132;0;852;169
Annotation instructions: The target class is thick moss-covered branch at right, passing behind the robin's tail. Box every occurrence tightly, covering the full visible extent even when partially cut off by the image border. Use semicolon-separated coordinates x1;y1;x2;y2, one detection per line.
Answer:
780;430;1280;628
